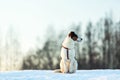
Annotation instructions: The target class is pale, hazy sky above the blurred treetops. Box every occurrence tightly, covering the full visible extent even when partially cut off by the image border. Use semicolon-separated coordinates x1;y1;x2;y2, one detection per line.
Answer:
0;0;120;49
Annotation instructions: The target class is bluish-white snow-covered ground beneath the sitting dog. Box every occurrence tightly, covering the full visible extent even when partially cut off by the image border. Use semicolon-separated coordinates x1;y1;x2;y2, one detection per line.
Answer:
0;70;120;80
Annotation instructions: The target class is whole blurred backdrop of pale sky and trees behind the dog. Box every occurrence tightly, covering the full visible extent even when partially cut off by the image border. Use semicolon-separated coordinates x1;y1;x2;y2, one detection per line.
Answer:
0;0;120;71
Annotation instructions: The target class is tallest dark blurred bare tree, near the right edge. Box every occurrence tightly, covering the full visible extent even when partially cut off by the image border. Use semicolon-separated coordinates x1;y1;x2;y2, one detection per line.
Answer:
103;18;113;68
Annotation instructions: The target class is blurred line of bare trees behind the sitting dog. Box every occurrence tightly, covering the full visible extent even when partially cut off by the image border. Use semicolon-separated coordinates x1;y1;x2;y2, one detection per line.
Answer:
0;16;120;70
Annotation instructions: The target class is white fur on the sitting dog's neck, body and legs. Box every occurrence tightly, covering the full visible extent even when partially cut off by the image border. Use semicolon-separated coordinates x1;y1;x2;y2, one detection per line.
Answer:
60;36;78;73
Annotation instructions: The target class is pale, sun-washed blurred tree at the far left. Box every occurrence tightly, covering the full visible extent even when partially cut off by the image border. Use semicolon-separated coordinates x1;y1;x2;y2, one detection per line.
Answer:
3;26;22;70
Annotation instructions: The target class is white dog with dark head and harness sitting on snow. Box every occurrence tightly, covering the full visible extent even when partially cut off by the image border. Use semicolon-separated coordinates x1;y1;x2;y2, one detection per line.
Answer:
55;31;82;73
